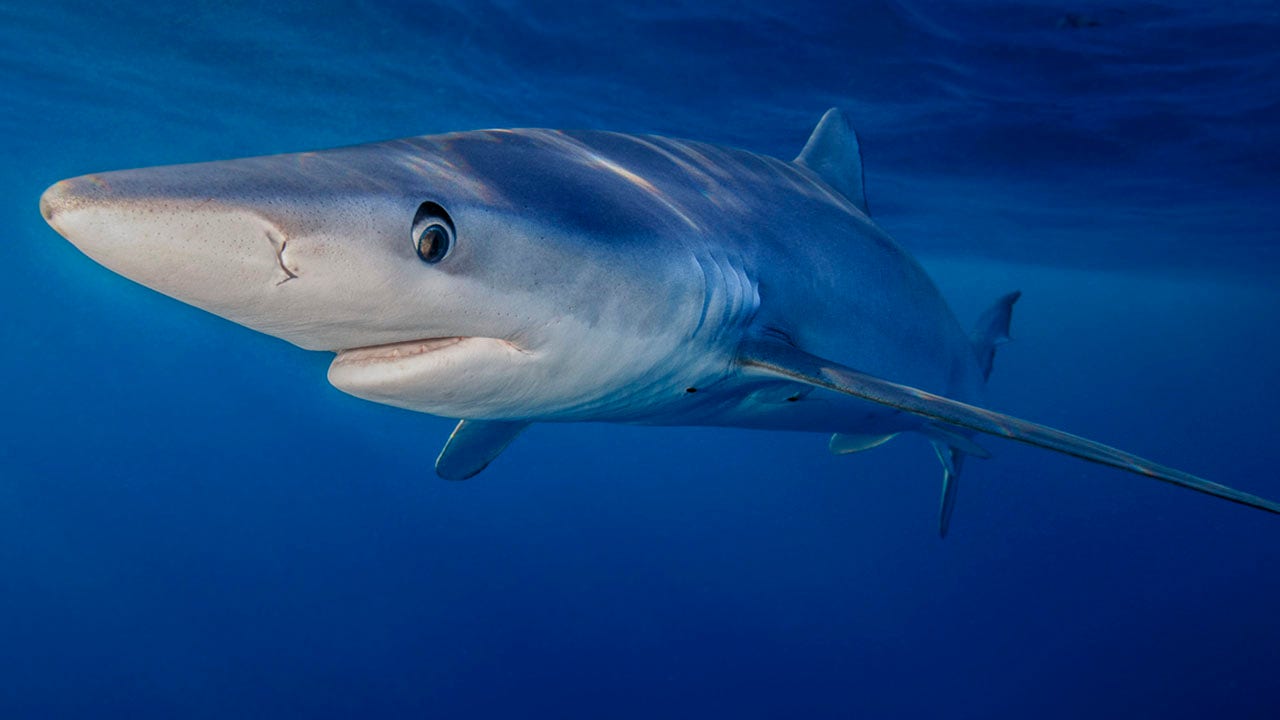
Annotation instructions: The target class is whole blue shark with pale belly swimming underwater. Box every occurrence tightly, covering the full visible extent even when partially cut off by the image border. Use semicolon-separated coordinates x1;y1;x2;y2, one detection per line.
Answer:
40;109;1280;536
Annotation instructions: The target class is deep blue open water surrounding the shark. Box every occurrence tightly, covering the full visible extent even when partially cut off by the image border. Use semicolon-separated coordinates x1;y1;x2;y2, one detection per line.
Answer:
0;0;1280;717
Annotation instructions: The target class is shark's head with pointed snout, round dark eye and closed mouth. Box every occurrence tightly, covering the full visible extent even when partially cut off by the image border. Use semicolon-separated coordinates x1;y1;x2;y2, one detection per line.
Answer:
41;132;732;419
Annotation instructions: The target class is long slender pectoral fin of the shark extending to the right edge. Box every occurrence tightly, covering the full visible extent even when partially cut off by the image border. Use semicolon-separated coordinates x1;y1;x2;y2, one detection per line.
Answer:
739;341;1280;514
